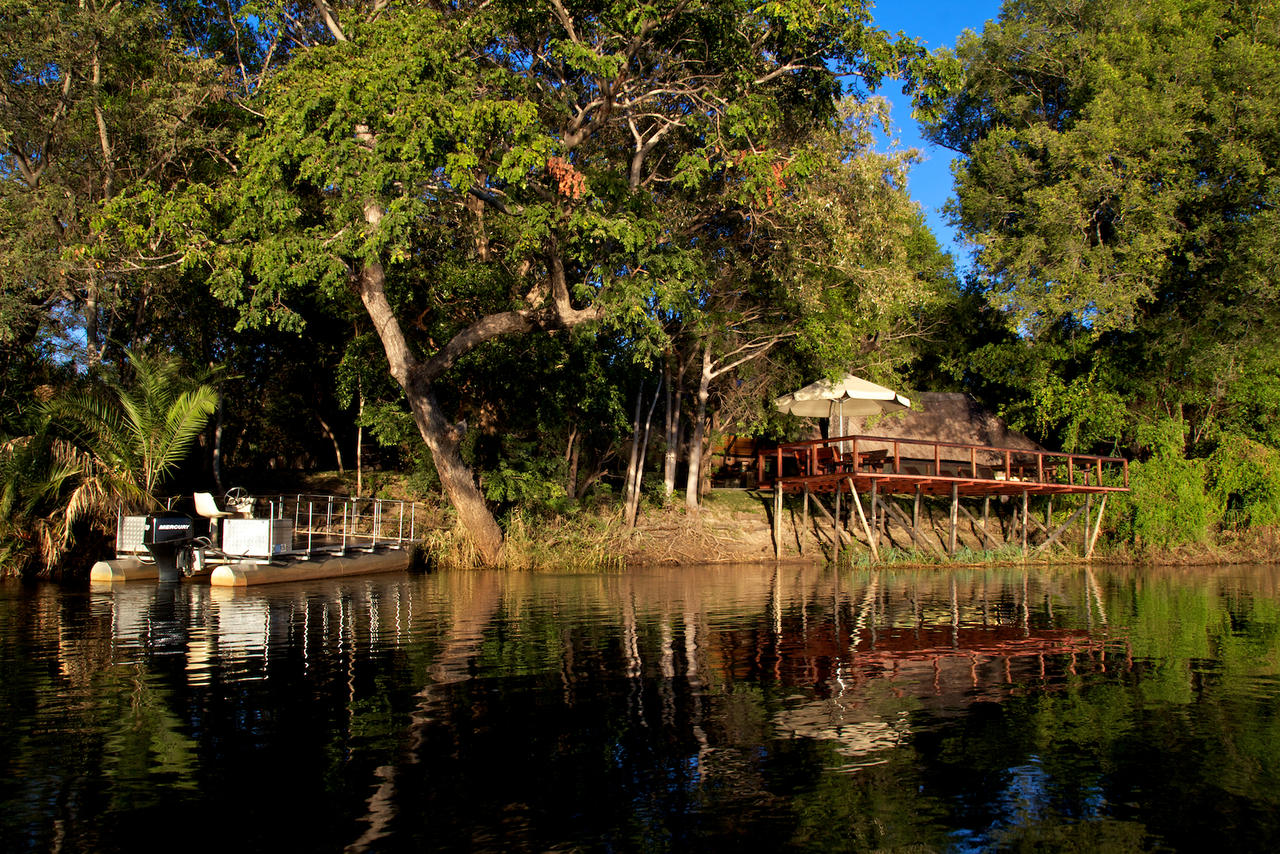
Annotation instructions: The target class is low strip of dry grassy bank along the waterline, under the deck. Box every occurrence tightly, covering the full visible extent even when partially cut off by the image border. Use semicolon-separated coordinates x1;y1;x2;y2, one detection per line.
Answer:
302;472;1280;571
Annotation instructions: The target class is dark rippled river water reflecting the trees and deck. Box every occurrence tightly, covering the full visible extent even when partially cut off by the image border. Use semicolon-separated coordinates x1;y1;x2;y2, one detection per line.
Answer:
0;566;1280;854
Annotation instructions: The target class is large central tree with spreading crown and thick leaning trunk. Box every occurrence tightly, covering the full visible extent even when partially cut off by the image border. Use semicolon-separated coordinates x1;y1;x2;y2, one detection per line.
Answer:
211;0;914;562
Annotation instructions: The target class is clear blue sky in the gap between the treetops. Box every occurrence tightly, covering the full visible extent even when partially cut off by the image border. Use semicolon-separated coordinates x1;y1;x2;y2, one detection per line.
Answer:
872;0;1001;258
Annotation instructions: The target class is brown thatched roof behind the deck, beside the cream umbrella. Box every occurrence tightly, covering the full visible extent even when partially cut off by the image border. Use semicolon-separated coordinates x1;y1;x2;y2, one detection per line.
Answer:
845;392;1046;460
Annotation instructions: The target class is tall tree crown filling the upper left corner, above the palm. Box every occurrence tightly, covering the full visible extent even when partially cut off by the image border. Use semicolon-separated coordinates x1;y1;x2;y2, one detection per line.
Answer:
0;0;234;361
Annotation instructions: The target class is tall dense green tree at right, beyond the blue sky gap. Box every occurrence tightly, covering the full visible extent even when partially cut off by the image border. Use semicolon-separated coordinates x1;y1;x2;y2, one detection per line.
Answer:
931;0;1280;453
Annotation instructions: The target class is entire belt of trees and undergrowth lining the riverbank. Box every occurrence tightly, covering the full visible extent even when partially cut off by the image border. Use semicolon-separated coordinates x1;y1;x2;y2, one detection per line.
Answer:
0;0;1280;576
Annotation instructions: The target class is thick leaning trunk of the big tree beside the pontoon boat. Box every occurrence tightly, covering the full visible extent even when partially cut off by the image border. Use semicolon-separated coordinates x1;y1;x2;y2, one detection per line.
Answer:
360;224;503;566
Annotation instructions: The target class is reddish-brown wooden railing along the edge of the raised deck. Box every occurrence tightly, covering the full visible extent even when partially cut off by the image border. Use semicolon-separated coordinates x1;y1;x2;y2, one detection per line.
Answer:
755;435;1129;489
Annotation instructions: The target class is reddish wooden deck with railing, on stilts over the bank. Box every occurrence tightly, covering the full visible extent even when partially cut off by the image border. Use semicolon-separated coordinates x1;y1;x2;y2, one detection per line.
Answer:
755;435;1129;560
